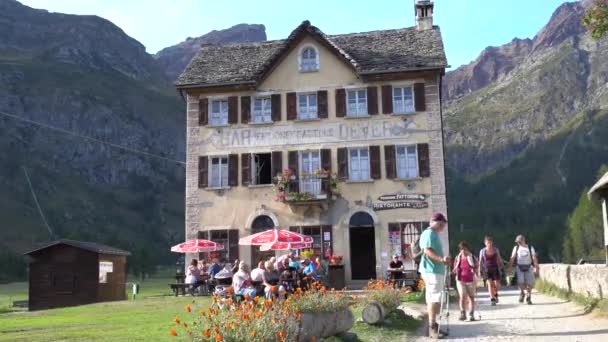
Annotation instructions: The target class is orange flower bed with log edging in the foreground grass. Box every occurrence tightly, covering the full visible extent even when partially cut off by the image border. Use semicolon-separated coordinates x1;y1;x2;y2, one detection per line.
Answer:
170;282;354;341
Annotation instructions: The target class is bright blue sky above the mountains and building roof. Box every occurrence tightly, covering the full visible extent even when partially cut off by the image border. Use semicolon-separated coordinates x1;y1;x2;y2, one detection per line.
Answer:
20;0;565;67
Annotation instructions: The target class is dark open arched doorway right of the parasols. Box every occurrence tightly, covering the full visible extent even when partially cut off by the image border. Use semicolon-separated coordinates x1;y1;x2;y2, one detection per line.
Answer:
348;211;376;280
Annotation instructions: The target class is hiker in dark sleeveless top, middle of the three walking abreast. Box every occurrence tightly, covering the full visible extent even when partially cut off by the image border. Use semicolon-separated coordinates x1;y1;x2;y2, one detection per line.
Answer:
478;235;505;306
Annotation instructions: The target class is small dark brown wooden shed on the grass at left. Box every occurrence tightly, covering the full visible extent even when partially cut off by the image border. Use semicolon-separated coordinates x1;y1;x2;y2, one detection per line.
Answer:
25;239;130;310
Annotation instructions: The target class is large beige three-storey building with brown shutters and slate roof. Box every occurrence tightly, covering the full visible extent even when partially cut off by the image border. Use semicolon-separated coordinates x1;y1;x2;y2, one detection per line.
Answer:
176;1;447;283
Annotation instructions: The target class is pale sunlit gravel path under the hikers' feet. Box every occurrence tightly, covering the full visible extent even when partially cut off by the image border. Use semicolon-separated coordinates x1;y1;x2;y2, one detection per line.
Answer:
408;289;608;342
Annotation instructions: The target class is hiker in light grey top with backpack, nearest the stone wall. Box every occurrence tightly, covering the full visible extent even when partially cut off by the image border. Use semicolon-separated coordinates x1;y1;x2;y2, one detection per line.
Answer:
509;235;538;305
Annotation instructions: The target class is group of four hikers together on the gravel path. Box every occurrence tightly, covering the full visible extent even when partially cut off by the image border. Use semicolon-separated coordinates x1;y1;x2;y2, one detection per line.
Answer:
419;213;539;338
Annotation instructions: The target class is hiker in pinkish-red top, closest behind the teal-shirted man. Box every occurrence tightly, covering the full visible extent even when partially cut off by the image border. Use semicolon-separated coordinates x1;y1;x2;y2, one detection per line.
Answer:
452;241;477;322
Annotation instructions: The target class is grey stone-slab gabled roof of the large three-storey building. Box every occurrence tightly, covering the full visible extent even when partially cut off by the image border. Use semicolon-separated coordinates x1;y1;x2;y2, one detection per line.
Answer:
175;21;447;88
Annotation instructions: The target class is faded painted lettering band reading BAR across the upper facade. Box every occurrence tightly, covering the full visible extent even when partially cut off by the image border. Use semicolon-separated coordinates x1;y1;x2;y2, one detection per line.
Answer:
202;119;421;149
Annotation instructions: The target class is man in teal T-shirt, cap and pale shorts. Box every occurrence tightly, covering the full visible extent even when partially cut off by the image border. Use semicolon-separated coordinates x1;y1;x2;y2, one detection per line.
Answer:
418;213;450;338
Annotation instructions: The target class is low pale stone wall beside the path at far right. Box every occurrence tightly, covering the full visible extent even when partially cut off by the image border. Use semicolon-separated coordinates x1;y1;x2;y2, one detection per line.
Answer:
540;264;608;299
